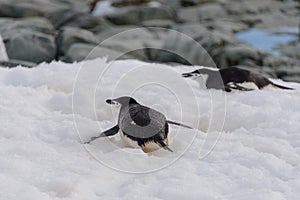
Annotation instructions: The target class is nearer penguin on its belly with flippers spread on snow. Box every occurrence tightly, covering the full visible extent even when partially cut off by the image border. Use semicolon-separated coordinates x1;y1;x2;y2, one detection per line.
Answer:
85;96;192;153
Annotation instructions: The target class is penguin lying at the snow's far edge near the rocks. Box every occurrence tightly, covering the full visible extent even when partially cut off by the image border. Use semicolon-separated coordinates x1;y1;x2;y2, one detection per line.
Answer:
182;67;293;92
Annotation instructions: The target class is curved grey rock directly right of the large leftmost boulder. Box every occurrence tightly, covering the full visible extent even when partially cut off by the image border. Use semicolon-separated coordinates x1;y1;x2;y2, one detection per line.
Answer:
56;27;99;56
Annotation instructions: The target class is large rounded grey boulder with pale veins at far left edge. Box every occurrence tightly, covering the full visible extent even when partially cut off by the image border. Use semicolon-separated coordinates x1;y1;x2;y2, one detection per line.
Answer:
0;18;56;63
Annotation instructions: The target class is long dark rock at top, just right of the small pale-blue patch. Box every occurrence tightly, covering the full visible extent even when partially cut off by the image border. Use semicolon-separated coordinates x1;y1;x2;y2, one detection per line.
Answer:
105;6;177;25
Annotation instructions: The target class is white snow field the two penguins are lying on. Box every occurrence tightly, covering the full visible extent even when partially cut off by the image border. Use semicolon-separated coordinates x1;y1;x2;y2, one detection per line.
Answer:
0;59;300;200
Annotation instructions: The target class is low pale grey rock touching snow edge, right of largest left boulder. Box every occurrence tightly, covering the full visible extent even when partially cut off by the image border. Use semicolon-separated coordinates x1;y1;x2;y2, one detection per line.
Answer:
64;43;133;62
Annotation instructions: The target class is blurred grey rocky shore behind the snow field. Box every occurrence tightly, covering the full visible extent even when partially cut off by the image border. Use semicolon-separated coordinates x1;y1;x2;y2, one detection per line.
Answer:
0;0;300;82
